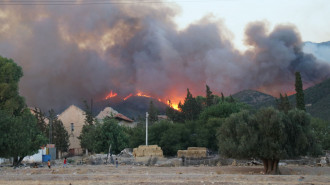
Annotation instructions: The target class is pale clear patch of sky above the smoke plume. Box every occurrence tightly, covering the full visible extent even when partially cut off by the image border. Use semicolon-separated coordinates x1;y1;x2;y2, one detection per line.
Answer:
170;0;330;49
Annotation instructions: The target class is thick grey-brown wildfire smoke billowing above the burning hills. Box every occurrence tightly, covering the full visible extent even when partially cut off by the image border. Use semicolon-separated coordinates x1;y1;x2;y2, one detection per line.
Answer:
0;3;330;110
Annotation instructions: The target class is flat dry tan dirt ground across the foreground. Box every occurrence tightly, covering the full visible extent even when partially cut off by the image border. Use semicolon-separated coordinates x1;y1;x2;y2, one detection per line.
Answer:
0;165;330;185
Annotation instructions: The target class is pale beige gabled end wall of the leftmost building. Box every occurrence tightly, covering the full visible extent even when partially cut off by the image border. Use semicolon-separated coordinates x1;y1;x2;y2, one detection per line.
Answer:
58;105;85;155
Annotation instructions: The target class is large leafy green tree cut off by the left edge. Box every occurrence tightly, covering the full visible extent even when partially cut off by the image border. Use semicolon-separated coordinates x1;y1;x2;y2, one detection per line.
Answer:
0;57;46;166
